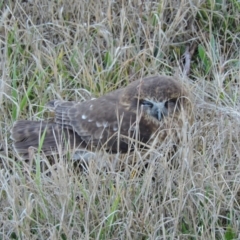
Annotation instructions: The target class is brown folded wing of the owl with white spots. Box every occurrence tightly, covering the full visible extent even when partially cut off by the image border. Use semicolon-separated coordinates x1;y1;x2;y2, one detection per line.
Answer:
48;90;136;152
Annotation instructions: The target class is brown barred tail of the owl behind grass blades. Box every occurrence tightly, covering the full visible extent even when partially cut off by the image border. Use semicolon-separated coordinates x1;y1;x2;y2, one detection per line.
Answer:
11;120;83;159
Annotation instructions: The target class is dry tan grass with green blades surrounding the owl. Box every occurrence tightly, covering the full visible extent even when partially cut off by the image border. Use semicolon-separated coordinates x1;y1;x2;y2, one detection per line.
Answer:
0;0;240;240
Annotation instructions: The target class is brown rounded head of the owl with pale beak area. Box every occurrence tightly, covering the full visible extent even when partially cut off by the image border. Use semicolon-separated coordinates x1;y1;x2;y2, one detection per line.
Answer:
120;76;192;125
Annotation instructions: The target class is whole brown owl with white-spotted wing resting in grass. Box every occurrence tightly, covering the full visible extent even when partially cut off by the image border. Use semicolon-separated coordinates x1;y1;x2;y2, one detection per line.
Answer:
11;76;192;158
